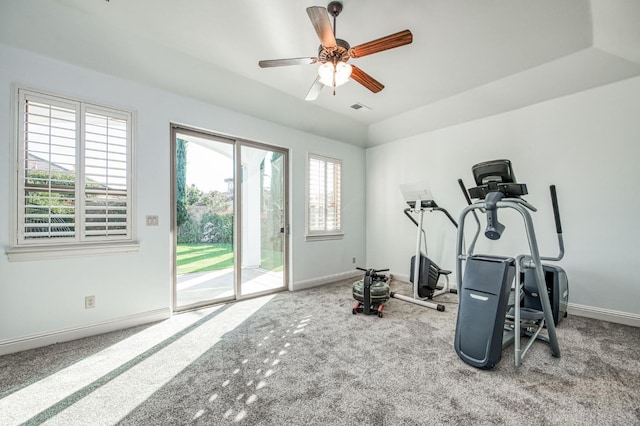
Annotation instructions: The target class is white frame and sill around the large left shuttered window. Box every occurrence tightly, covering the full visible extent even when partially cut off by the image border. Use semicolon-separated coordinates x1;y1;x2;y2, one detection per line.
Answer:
6;85;139;261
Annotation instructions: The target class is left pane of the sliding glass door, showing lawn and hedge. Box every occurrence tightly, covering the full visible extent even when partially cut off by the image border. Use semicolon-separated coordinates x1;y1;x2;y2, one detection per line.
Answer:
174;131;235;309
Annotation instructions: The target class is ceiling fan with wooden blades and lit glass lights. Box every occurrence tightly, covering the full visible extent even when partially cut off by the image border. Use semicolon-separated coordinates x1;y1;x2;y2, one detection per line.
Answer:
258;1;413;101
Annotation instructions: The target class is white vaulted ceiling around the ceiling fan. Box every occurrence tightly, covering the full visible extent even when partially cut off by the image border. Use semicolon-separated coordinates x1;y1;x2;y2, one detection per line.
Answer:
0;0;640;146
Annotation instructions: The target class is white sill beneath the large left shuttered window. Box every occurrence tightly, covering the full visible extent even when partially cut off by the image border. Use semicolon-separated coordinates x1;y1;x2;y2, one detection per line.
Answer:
6;241;140;262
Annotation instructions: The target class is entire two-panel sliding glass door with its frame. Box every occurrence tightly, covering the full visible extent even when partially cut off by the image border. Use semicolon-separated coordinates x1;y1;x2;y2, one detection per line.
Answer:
172;126;288;310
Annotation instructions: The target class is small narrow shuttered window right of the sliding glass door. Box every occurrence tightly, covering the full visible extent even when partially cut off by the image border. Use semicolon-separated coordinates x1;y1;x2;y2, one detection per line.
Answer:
307;154;342;240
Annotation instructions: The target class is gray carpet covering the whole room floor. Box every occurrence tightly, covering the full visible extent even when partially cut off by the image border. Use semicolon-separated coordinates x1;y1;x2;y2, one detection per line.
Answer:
0;282;640;425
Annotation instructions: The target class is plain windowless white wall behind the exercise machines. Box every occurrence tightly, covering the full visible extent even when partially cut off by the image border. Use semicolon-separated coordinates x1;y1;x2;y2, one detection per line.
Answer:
367;78;640;318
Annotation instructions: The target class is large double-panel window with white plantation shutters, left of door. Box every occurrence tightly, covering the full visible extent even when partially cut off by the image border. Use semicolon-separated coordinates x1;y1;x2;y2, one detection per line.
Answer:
17;89;132;245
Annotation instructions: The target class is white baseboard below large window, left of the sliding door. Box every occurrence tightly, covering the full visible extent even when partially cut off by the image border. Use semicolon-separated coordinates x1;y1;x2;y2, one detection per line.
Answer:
0;307;171;355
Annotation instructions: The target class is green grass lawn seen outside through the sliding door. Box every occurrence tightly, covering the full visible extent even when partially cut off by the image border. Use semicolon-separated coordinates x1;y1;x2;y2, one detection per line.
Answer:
176;244;282;275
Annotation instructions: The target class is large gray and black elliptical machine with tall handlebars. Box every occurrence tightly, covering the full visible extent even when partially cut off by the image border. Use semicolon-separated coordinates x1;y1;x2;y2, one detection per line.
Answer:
454;160;569;369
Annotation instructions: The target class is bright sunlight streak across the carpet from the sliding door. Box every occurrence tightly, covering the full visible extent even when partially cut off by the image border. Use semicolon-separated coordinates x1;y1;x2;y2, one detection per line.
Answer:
0;295;274;424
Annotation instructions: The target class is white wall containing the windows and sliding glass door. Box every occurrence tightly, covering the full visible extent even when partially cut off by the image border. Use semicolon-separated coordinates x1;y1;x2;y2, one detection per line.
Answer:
0;44;365;351
